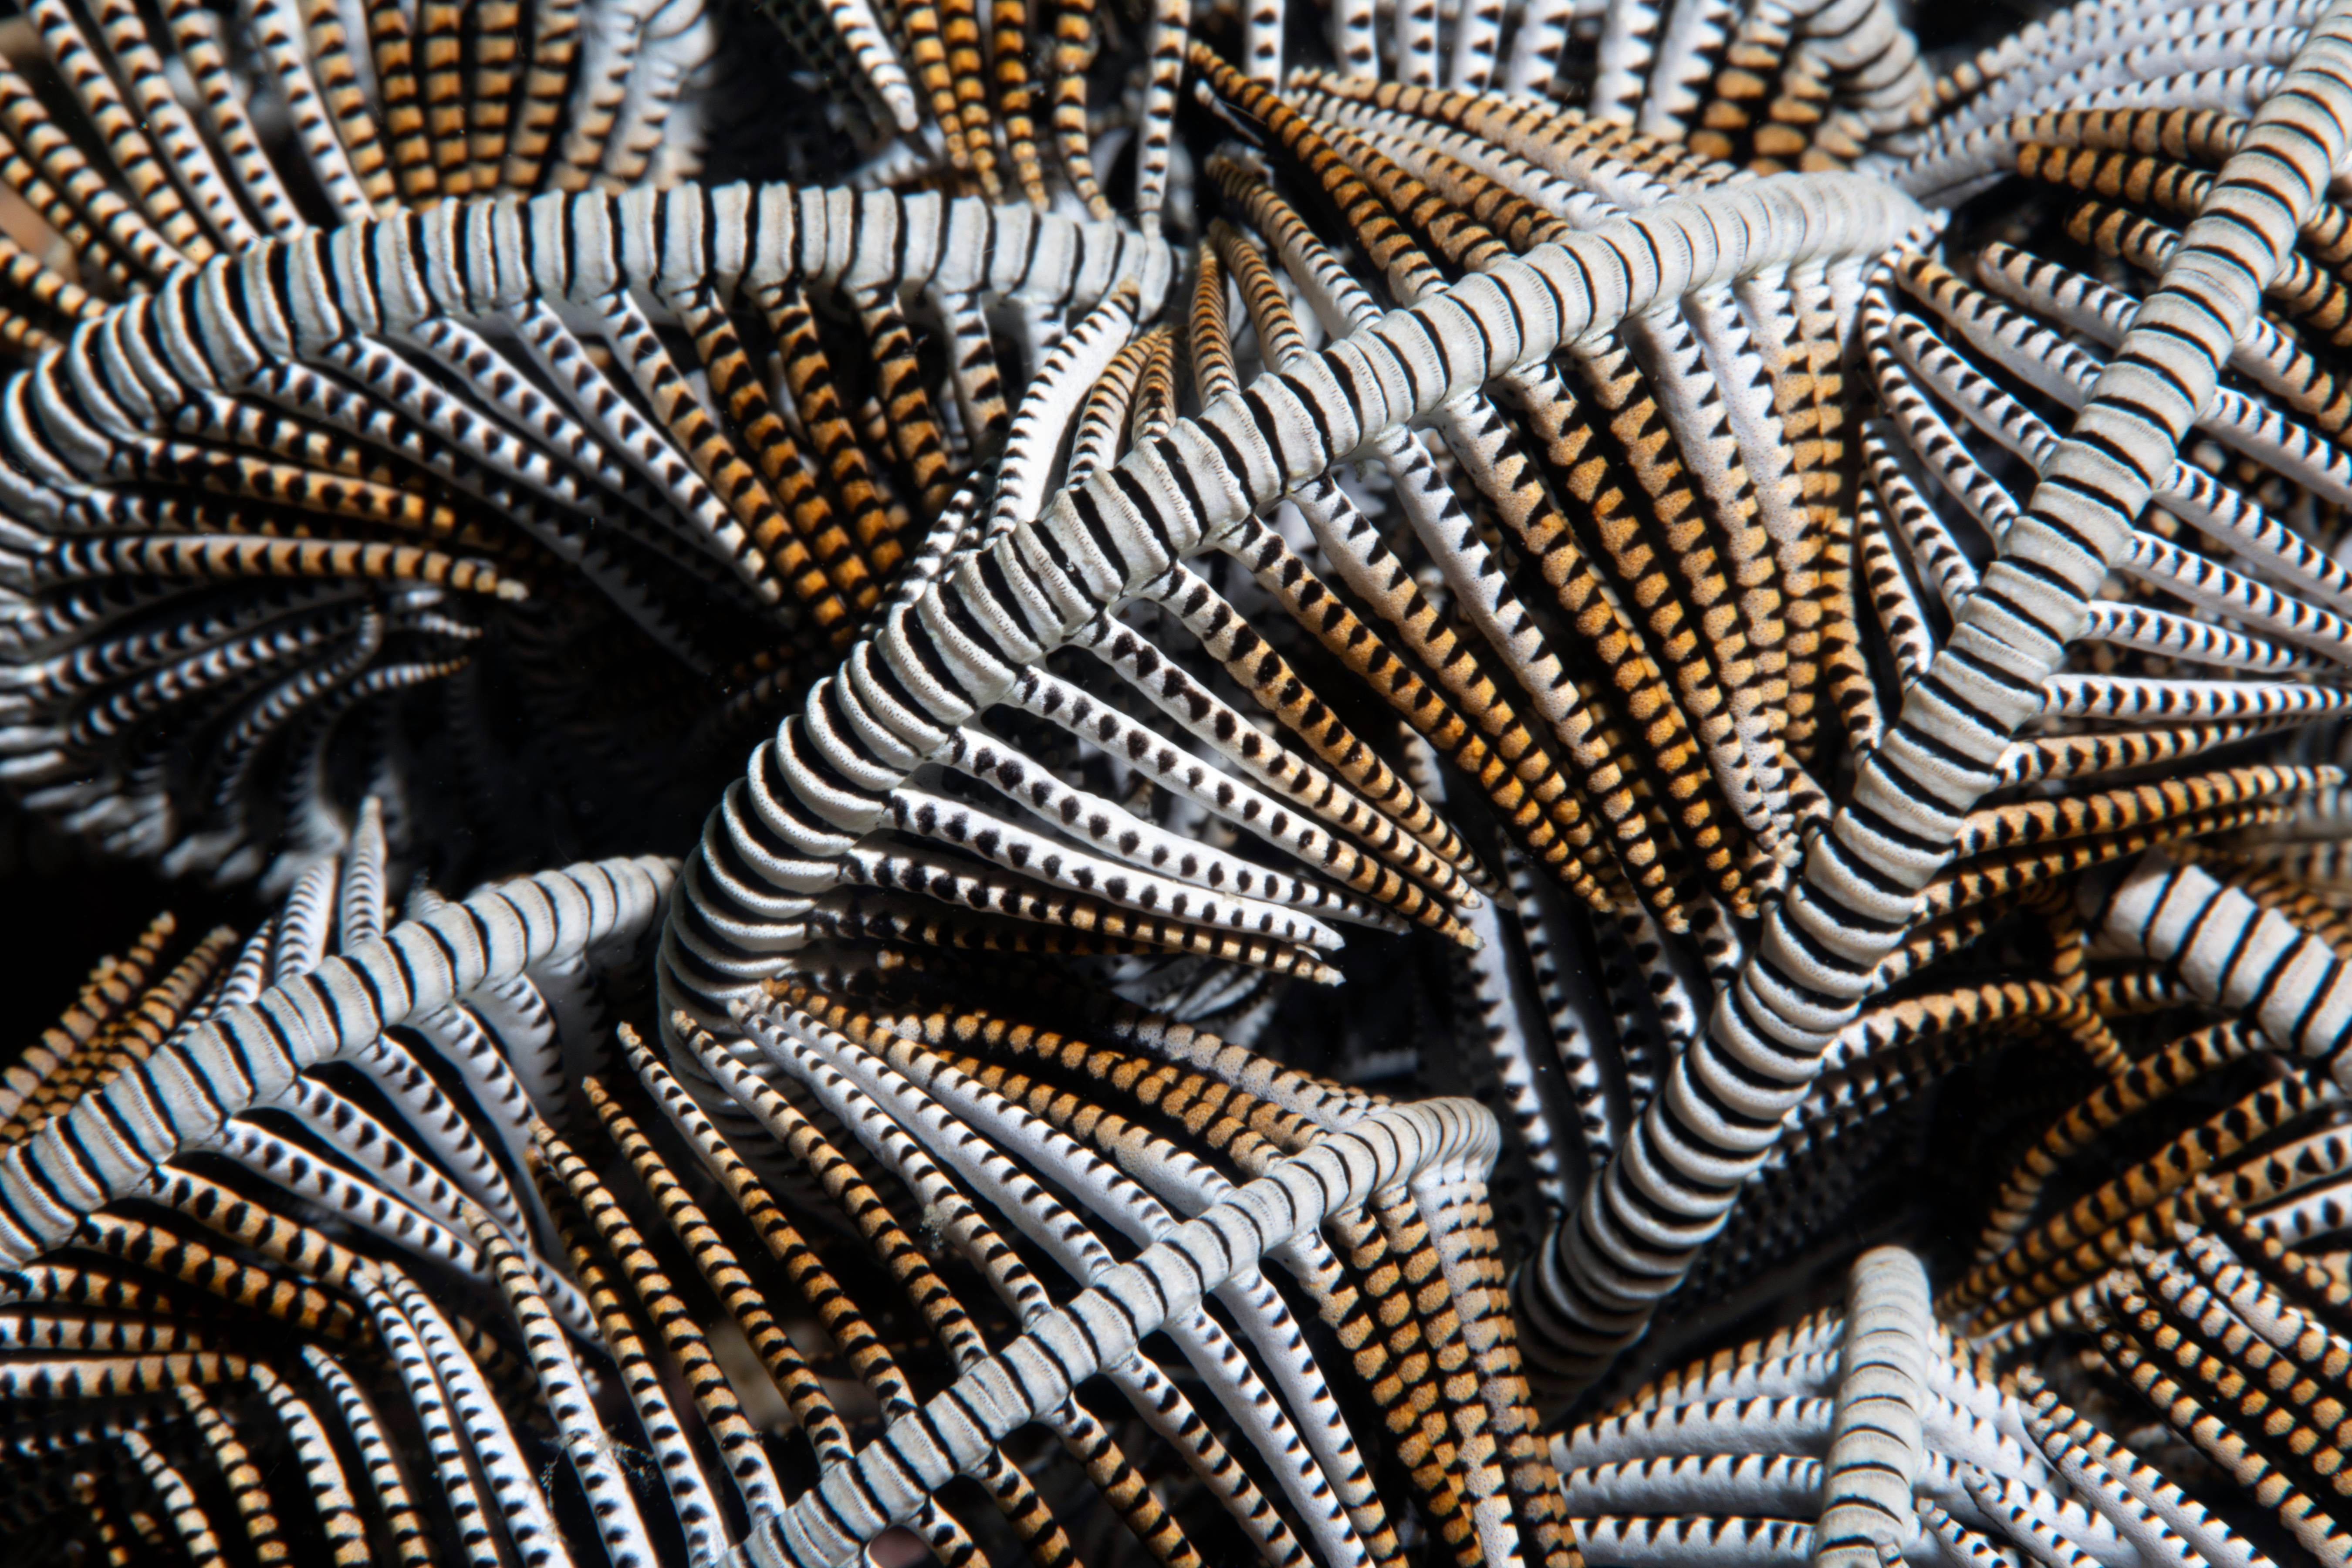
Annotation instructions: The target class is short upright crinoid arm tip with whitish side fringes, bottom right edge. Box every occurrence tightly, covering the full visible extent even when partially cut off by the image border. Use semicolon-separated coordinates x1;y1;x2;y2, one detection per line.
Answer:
1552;1248;2270;1568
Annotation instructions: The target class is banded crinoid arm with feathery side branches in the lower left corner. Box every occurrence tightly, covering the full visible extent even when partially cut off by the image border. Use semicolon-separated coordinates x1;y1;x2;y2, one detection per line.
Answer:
0;841;686;1563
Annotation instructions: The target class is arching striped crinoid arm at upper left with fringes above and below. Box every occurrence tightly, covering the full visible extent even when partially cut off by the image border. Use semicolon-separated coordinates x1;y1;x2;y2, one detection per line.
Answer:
0;5;1164;882
